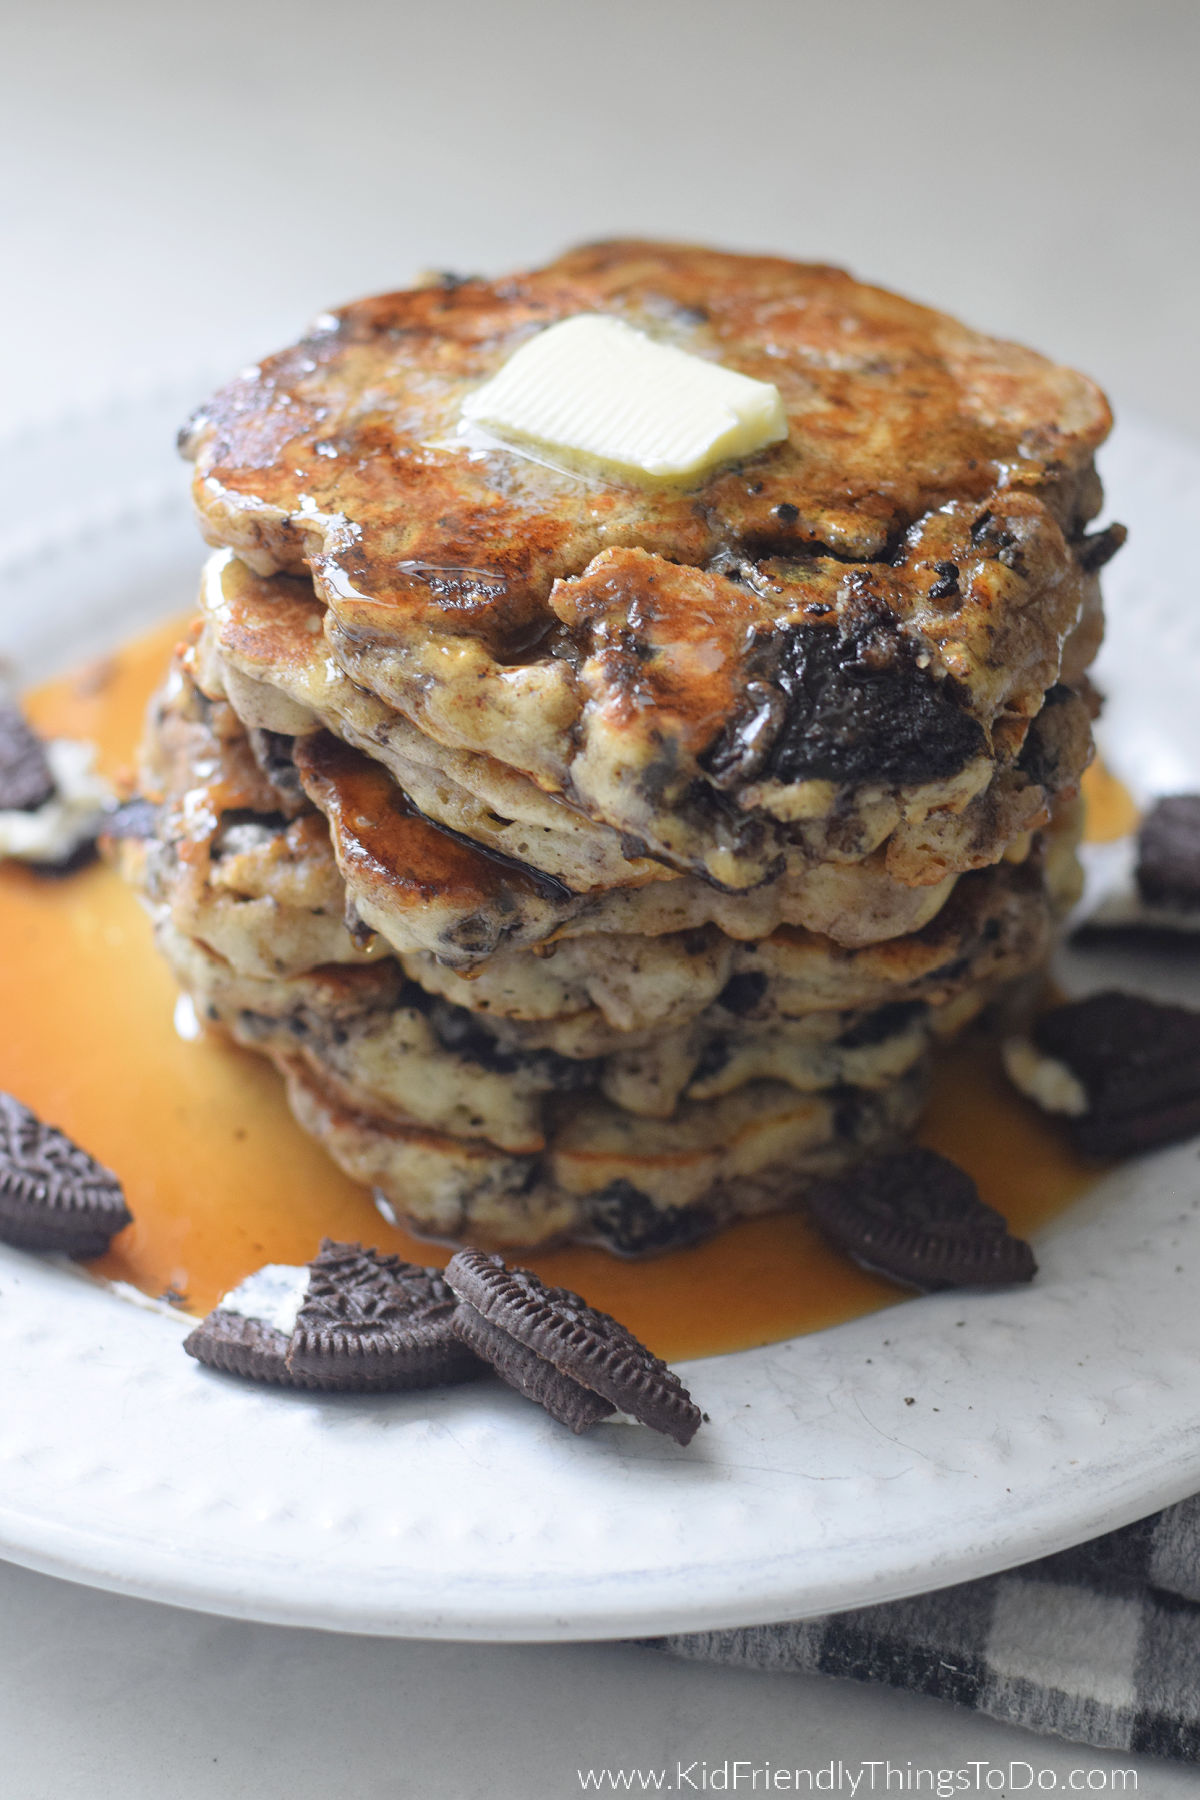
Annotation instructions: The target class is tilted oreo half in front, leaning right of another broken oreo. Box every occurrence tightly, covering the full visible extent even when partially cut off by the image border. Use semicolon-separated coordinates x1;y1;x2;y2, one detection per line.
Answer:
446;1249;702;1444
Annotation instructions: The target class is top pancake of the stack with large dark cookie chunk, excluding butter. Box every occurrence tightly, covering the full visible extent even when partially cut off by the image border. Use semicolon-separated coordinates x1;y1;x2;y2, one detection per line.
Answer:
185;243;1110;887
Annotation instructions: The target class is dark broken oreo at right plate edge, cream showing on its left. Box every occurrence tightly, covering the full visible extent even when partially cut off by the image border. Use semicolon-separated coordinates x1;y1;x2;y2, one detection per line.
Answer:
1033;990;1200;1156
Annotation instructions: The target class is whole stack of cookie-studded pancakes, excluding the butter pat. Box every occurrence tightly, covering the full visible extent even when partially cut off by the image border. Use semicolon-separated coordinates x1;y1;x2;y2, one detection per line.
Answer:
121;243;1119;1253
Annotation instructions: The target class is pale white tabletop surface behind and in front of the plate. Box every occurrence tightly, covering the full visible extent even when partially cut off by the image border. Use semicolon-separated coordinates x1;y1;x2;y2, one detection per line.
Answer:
0;0;1200;1800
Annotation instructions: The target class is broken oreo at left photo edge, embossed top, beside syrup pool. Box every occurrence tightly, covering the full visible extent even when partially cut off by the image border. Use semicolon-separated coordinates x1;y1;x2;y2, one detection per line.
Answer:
0;1093;133;1258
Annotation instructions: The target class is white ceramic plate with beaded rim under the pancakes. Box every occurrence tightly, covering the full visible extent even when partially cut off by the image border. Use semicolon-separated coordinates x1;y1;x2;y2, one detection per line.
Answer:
0;397;1200;1640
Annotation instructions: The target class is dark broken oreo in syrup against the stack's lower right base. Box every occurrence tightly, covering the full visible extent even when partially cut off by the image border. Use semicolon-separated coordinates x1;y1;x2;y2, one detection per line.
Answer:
804;1148;1038;1292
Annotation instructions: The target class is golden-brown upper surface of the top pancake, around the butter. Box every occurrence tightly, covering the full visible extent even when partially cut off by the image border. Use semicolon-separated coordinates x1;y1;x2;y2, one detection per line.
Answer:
187;241;1110;626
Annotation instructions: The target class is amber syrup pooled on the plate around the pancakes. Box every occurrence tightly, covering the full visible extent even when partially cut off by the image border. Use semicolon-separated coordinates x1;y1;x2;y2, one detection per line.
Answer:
0;625;1115;1359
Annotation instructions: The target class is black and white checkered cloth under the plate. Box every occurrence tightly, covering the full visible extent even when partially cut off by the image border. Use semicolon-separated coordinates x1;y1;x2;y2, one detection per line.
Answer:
655;1496;1200;1762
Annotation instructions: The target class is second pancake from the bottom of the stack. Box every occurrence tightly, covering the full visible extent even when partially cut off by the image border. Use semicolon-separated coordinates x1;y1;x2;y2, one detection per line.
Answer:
158;922;949;1150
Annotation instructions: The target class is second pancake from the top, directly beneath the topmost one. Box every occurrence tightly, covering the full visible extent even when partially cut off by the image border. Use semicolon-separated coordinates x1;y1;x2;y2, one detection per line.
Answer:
198;554;1092;907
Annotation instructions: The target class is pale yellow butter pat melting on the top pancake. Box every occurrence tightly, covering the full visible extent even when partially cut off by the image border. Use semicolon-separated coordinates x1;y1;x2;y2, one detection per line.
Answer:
462;313;788;481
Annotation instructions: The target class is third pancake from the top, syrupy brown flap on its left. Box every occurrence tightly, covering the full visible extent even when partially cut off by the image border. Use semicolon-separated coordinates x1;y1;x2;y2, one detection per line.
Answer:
124;652;1051;1057
